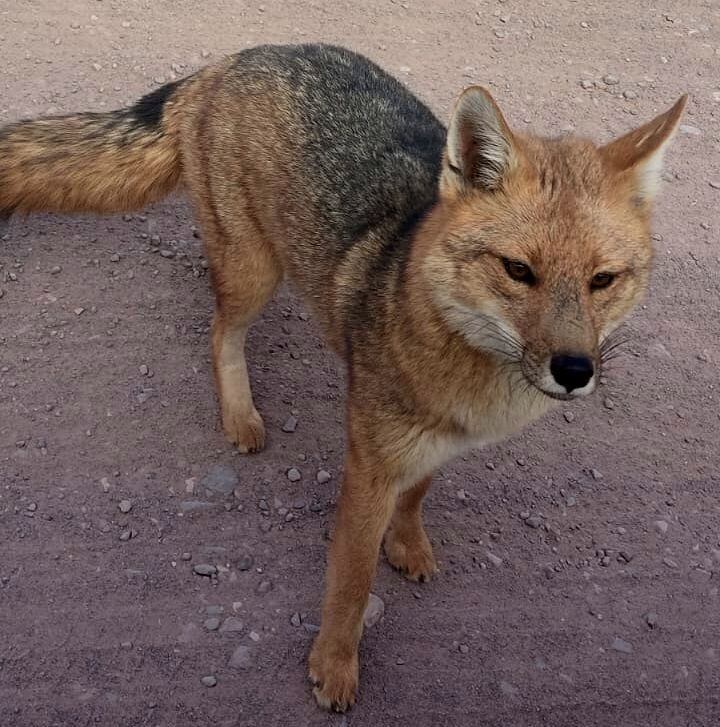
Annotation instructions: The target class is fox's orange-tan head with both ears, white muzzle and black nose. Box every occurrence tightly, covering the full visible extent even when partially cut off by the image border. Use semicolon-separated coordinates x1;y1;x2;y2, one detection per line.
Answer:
423;87;687;399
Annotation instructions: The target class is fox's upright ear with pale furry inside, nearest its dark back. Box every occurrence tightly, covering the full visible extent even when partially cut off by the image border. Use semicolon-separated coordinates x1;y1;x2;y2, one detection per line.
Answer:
443;86;517;191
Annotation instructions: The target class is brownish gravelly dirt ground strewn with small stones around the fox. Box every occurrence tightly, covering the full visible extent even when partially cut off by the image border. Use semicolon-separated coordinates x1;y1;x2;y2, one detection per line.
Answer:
0;0;720;727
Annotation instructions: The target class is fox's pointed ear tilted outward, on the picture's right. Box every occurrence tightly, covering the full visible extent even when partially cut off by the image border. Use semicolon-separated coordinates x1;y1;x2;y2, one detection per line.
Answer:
600;94;687;205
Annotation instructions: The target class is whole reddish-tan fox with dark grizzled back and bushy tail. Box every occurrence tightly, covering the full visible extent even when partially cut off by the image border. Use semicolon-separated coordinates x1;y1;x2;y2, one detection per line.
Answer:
0;44;687;711
